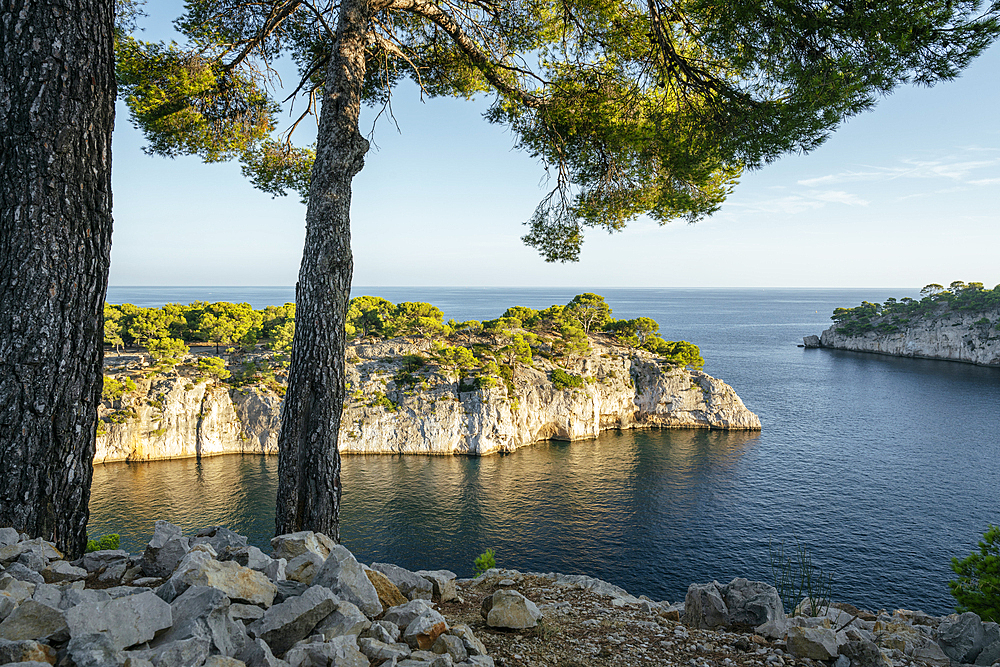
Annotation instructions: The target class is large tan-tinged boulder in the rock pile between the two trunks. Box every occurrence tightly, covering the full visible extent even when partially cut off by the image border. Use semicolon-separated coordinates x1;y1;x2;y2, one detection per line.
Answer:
157;549;278;607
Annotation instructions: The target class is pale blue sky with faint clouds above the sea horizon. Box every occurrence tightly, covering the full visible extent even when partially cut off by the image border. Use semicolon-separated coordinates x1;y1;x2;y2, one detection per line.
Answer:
110;8;1000;289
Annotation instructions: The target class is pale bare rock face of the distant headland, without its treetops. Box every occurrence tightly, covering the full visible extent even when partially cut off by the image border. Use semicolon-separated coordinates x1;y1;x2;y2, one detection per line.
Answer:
806;307;1000;366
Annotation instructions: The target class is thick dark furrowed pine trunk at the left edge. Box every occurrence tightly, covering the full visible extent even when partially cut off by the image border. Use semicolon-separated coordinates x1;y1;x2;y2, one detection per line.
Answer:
0;0;115;557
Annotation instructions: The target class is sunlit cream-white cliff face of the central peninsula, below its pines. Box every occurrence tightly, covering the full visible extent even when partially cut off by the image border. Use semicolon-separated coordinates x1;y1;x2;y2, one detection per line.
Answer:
94;339;760;462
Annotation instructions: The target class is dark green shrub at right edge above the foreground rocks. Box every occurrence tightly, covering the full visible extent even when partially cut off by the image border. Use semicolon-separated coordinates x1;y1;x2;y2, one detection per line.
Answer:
948;524;1000;623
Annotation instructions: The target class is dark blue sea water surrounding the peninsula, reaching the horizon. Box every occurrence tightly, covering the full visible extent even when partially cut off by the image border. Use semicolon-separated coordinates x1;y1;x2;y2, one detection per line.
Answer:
91;287;1000;613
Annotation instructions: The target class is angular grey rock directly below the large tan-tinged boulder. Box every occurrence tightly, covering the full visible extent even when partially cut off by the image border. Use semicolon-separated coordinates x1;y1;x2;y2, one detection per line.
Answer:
151;586;248;657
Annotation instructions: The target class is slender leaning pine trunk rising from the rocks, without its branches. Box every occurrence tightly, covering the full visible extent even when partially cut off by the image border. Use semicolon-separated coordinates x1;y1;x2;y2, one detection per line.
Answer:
275;0;372;542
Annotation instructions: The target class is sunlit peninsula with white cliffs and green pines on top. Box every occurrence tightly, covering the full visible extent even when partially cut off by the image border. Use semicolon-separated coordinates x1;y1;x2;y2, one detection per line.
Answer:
95;295;760;462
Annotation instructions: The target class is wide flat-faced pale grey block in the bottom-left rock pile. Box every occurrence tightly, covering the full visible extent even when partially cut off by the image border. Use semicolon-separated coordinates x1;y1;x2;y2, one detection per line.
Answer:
66;592;173;648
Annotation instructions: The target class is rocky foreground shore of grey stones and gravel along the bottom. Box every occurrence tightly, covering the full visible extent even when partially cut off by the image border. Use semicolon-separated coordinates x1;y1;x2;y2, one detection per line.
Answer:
0;521;1000;667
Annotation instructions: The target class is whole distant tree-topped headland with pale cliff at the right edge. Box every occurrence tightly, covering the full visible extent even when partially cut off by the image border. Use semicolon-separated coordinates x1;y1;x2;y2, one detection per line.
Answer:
805;283;1000;366
